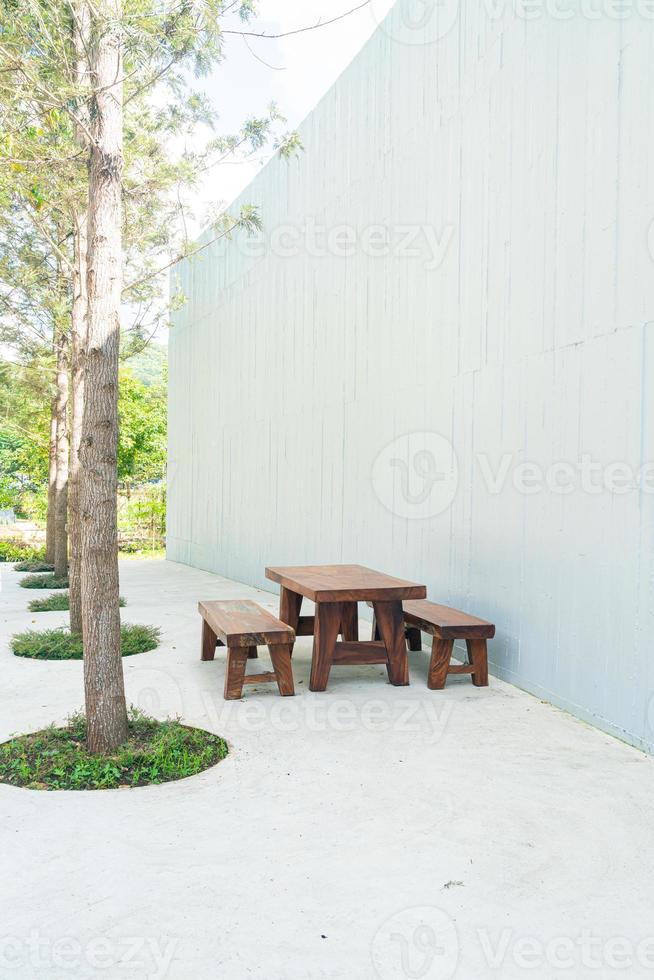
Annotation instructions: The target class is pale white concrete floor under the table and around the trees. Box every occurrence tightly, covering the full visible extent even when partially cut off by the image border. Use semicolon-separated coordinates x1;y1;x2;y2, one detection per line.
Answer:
0;561;654;980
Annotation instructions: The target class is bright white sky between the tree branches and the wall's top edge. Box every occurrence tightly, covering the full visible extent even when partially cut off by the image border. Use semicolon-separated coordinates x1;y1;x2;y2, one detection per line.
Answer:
195;0;394;212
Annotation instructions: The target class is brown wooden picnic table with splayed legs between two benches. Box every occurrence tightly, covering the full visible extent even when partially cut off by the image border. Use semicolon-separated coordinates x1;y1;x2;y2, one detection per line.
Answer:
266;565;427;691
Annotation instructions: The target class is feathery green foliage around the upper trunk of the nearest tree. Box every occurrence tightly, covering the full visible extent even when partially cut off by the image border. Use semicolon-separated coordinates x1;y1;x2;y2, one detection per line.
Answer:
0;0;300;356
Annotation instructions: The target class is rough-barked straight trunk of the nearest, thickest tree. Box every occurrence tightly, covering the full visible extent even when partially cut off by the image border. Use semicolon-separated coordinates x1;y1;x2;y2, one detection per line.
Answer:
80;0;128;752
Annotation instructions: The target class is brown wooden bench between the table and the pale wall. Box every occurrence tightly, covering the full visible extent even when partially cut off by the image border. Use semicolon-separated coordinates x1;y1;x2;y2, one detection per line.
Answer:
373;599;495;691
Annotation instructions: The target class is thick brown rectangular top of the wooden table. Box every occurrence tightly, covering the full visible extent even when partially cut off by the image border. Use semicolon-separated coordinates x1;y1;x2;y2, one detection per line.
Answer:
266;565;427;602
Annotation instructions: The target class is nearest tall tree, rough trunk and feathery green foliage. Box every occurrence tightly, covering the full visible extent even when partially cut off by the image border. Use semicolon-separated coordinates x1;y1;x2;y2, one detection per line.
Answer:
0;0;298;751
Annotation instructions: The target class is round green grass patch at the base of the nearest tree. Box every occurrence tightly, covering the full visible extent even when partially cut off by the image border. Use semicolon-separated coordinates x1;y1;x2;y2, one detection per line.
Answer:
0;709;229;790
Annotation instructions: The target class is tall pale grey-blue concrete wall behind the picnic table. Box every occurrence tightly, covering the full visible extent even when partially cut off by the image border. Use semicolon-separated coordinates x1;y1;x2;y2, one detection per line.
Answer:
168;0;654;750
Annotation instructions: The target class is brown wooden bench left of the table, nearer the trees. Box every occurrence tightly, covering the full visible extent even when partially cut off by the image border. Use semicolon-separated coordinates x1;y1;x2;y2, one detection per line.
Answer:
198;599;295;701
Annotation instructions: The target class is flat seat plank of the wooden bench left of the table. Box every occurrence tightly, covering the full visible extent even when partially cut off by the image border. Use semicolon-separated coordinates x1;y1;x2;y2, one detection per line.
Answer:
198;599;295;647
